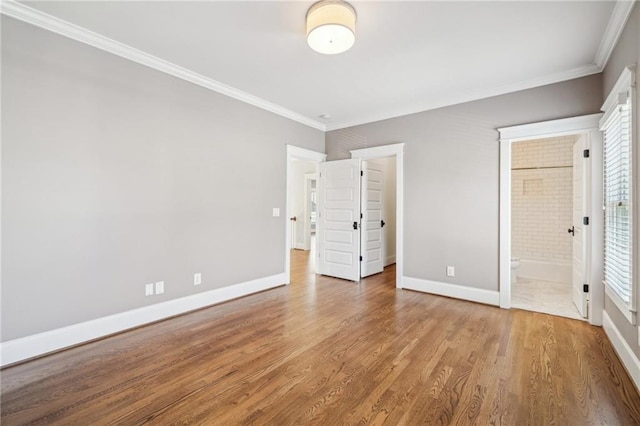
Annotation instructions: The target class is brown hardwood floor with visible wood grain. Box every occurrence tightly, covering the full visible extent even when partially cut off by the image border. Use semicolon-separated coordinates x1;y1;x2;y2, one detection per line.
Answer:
0;251;640;425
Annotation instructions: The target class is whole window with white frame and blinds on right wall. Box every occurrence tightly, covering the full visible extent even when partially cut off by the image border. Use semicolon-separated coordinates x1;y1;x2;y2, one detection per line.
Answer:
600;67;636;324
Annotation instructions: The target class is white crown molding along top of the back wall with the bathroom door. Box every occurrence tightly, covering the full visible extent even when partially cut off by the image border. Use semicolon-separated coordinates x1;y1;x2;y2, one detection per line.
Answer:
326;64;601;131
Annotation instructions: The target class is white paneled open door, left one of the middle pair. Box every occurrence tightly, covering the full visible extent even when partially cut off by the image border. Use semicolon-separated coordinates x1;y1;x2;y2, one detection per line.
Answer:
316;158;360;281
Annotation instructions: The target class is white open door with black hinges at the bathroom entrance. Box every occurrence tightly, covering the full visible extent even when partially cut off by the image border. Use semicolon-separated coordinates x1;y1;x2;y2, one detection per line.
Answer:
569;135;590;318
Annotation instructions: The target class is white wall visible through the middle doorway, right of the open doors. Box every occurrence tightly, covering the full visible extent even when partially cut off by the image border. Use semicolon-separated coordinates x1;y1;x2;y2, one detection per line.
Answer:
369;157;396;266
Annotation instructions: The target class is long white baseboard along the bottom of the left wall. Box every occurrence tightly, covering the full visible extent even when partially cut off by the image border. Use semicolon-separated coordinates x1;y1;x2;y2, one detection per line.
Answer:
0;273;286;366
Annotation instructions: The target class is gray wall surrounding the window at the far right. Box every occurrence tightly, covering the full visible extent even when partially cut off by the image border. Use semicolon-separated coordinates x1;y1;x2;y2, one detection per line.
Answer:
602;3;640;357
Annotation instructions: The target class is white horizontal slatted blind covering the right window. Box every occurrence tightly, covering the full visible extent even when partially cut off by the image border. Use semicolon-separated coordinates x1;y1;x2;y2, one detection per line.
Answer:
603;96;633;304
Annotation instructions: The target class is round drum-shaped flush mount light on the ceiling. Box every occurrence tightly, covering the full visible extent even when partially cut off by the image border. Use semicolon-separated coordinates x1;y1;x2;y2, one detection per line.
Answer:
307;0;356;55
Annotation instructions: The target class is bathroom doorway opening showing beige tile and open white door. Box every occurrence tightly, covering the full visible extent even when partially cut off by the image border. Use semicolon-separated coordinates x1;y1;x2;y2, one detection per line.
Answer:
511;134;586;319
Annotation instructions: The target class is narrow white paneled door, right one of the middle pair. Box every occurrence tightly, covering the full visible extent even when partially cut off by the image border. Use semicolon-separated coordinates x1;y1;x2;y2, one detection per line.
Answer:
360;161;384;277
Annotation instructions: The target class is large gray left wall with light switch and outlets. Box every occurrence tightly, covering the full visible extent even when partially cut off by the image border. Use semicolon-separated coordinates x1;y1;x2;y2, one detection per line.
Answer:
2;16;324;341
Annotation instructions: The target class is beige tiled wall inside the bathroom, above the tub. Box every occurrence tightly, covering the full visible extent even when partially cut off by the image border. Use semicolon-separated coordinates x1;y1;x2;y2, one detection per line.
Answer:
511;136;578;263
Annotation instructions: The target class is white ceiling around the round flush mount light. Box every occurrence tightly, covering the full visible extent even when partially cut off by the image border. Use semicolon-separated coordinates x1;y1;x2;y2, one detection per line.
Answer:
12;1;630;129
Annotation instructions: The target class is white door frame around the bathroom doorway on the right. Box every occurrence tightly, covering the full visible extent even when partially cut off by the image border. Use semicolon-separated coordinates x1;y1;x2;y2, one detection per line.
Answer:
497;113;604;325
